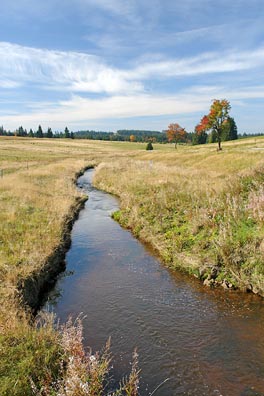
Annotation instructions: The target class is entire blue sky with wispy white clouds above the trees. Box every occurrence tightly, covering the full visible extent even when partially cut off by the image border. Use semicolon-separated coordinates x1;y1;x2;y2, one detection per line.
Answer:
0;0;264;133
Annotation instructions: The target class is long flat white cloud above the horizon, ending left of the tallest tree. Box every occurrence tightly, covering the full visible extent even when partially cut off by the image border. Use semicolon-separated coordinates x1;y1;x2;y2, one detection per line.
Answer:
1;94;206;128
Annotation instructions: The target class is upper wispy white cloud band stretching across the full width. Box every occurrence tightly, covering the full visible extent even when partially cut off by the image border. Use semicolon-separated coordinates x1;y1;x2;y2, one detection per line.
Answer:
0;43;264;94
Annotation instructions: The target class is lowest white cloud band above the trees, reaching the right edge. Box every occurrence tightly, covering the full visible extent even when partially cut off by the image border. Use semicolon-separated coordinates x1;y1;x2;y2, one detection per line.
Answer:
1;86;264;129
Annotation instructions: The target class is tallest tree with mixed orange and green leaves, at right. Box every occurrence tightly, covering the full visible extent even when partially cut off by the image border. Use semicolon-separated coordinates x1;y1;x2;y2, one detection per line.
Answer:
195;99;231;150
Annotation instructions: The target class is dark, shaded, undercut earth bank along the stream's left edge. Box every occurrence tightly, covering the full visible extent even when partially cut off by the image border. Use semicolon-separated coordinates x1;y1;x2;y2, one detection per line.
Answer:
17;166;92;313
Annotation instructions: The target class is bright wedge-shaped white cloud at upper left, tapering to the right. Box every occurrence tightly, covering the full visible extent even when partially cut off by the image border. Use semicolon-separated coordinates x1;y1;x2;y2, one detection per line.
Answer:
0;43;142;93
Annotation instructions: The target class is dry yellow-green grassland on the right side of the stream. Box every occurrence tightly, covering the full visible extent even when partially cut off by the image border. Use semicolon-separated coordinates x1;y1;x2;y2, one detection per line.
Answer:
92;138;264;295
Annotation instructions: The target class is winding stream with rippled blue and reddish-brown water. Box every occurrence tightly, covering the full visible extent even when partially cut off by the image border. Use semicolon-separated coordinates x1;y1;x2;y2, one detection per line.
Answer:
44;170;264;396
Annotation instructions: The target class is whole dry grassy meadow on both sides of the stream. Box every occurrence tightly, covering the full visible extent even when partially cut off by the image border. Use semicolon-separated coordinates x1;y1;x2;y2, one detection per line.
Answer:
0;137;264;395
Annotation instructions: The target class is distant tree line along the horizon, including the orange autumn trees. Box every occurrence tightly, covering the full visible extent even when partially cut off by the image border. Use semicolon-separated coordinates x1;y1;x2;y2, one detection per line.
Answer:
0;117;264;147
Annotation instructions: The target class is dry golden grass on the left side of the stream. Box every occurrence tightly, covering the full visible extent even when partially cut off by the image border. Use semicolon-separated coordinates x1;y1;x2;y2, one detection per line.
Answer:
0;138;140;396
